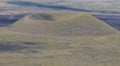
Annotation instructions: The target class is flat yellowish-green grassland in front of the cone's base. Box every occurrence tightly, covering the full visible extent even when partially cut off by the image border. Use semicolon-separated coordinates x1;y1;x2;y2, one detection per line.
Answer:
0;32;120;66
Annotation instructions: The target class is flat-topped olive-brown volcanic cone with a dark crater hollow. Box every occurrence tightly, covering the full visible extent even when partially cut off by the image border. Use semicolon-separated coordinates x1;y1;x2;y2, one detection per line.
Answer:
8;12;118;36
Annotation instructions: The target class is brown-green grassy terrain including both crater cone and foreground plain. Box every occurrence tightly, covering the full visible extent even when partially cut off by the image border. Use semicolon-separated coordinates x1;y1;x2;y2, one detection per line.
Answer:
0;12;120;66
